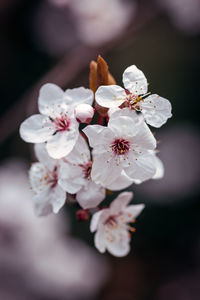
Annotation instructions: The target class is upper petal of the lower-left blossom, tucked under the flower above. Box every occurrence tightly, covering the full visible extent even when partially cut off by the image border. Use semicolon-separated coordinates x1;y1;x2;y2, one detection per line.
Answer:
34;143;56;170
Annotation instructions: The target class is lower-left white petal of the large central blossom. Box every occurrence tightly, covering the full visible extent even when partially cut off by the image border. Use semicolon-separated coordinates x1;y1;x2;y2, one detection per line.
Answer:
91;153;122;187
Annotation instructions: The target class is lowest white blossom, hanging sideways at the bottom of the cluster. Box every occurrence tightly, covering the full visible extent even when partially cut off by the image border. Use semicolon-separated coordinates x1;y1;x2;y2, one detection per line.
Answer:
90;192;144;257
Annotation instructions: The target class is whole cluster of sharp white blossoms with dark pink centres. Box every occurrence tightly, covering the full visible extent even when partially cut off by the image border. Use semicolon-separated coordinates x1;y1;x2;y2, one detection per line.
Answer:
20;65;171;256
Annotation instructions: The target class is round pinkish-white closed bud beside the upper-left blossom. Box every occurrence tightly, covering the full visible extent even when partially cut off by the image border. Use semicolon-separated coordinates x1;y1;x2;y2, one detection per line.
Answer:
74;104;94;124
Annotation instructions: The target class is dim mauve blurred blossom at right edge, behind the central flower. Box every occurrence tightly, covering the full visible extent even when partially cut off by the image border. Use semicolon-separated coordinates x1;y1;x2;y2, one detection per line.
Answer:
134;124;200;204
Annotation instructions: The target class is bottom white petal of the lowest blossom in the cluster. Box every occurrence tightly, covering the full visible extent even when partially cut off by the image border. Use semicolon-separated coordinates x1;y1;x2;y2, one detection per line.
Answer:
105;230;130;257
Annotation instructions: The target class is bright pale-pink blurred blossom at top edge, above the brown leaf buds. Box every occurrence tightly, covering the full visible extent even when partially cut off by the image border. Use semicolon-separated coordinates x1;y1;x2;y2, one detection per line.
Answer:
69;0;135;46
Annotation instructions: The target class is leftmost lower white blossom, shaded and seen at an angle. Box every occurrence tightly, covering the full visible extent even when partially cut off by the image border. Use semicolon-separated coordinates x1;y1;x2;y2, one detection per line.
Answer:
29;144;66;216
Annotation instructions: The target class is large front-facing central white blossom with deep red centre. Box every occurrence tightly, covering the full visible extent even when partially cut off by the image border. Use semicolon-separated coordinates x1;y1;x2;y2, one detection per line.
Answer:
83;108;156;186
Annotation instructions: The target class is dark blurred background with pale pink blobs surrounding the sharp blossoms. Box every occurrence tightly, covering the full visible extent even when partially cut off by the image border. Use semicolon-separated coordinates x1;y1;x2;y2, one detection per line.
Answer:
0;0;200;300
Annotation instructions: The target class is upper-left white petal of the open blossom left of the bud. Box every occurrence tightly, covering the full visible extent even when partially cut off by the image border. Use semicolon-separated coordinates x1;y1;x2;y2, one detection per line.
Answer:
38;83;64;115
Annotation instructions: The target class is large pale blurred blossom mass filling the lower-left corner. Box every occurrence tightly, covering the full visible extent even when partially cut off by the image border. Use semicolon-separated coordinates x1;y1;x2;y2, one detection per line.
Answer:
0;161;108;300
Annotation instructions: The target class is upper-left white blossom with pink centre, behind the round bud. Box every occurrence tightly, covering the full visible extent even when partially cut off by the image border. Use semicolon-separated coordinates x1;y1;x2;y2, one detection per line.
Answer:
20;83;93;159
